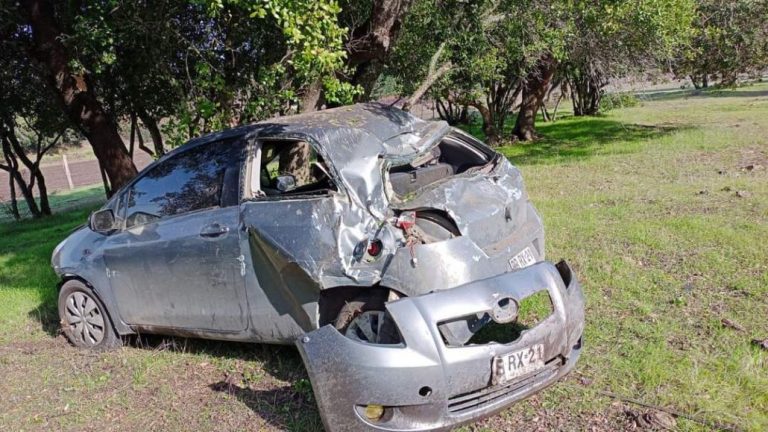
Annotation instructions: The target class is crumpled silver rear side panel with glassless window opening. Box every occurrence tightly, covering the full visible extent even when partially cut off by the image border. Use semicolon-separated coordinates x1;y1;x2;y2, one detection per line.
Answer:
241;140;344;343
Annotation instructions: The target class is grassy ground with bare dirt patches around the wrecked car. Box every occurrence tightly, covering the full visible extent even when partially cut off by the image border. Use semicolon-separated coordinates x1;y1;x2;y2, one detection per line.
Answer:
0;85;768;431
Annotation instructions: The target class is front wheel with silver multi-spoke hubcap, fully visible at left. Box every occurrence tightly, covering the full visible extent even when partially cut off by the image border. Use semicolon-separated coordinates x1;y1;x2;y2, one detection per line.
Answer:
59;280;121;350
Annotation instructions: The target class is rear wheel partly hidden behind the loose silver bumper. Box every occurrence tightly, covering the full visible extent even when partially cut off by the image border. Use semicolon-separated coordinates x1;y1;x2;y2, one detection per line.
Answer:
334;293;401;344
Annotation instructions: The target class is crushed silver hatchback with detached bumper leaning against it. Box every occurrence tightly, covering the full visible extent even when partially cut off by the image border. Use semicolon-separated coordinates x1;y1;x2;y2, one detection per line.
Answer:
52;104;584;431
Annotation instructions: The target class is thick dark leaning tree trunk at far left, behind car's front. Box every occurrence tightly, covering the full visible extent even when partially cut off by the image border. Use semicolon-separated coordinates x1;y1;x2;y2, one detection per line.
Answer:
21;0;136;190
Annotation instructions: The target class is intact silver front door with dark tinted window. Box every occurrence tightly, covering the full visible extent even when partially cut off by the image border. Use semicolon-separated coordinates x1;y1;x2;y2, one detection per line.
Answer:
104;140;248;332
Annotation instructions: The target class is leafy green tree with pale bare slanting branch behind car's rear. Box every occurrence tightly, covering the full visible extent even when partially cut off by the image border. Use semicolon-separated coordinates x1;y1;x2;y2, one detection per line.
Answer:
392;0;563;144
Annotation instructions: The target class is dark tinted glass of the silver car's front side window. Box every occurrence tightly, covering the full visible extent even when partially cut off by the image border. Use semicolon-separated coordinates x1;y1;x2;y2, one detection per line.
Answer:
125;139;243;228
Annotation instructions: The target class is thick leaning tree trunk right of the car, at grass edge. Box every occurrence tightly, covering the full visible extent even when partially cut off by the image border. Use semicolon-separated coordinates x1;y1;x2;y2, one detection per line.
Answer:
512;53;557;141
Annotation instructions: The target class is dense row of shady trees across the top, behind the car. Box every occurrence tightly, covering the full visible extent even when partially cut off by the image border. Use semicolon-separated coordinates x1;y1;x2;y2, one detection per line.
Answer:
0;0;768;218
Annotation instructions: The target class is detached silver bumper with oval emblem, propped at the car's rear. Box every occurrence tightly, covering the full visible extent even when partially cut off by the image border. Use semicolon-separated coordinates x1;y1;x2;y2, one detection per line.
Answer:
297;262;584;432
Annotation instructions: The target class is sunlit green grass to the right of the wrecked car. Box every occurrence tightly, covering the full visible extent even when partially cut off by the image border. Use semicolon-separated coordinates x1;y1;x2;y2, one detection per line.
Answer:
462;85;768;430
